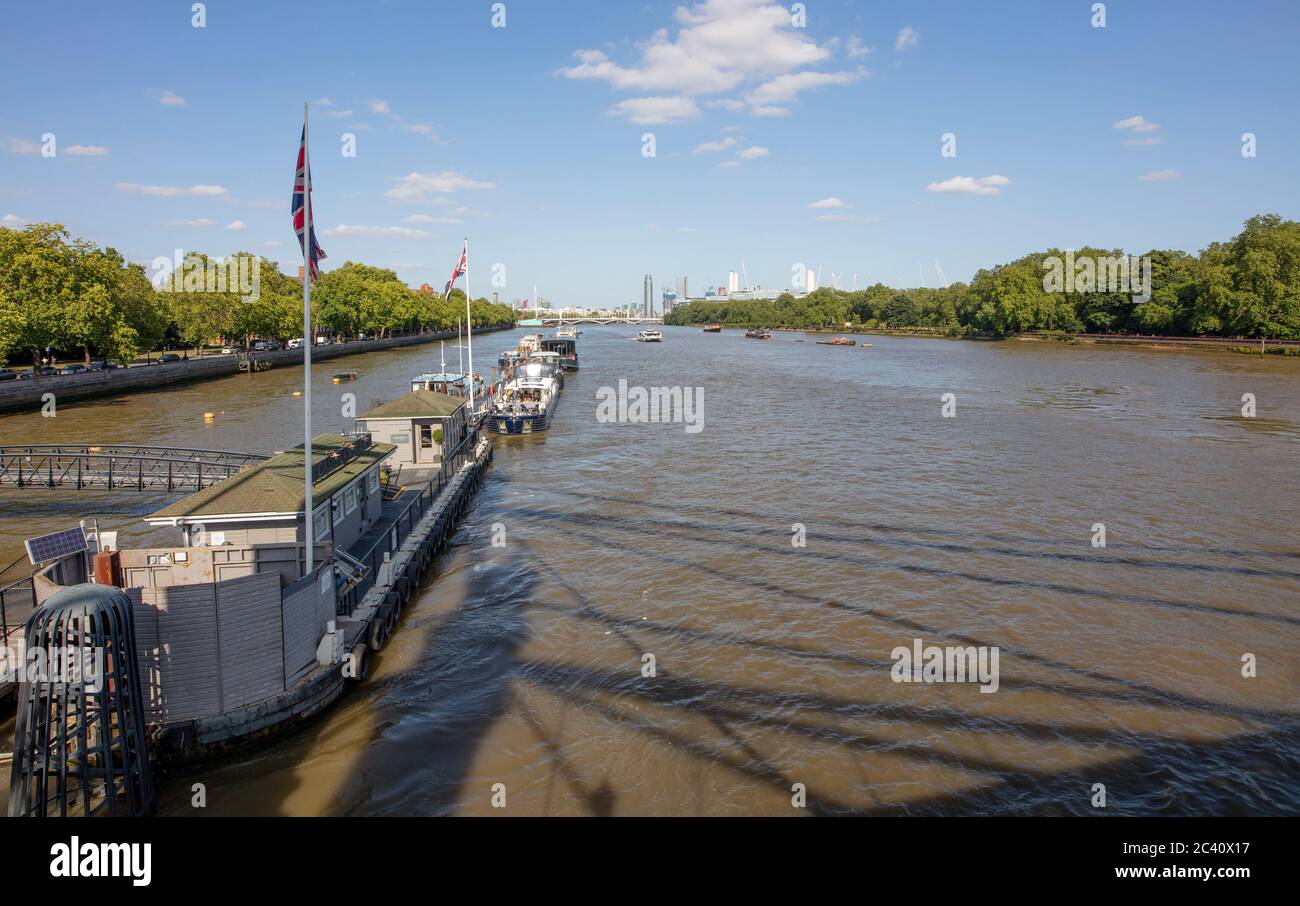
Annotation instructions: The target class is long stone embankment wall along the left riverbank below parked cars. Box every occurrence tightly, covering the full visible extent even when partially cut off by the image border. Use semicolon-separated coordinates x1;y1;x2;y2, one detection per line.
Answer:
0;328;508;412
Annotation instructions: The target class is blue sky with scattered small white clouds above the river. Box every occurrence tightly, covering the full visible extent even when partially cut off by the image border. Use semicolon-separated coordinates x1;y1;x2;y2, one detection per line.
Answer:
0;0;1300;305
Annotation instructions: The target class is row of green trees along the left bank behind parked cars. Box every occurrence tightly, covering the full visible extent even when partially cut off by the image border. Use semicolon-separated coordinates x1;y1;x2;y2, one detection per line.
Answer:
0;224;515;363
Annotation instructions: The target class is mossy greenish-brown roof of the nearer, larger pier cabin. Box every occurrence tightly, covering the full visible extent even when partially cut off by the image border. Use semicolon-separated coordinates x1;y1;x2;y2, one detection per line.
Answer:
146;434;397;520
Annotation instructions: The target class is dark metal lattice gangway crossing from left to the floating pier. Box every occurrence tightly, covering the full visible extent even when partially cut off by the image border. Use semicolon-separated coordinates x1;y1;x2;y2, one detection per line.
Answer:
0;443;269;491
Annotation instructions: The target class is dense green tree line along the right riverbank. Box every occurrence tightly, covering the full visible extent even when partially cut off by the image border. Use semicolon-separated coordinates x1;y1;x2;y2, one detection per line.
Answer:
664;214;1300;339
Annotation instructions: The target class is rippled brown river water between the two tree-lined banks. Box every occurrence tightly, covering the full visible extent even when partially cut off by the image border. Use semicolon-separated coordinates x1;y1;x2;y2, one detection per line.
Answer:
0;328;1300;815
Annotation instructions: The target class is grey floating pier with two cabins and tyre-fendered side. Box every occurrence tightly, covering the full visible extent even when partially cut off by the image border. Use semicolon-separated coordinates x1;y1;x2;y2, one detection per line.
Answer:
3;391;491;772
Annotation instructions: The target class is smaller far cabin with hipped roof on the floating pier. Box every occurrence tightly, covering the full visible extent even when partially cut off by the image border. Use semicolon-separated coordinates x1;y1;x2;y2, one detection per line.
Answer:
356;390;467;465
